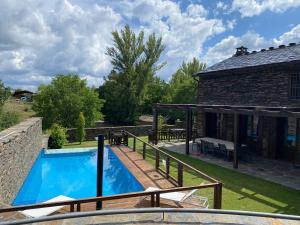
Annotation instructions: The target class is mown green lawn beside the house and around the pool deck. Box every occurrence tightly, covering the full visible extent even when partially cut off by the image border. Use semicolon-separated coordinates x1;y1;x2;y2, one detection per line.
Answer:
66;137;300;215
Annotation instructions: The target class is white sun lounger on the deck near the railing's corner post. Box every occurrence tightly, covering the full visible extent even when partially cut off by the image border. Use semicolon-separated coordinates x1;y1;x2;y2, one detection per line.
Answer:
145;187;208;208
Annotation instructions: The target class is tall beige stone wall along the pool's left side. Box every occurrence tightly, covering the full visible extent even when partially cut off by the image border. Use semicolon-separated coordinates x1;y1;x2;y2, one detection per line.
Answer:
0;117;43;204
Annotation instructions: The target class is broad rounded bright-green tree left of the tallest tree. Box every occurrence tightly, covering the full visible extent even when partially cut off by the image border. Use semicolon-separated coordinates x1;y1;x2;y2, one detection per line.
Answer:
33;74;103;128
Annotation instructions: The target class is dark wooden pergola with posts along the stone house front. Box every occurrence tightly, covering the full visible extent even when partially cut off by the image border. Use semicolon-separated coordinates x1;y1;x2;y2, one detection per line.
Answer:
152;103;300;168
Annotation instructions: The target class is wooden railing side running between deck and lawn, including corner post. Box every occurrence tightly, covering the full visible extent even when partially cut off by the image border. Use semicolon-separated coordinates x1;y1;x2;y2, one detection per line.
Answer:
123;131;222;209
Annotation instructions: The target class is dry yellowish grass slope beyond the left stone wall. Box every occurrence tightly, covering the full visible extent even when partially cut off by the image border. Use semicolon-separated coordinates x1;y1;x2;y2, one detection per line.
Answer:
3;97;35;122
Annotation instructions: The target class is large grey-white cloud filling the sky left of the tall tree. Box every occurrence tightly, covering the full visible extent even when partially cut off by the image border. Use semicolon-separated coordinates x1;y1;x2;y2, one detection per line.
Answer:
0;0;121;88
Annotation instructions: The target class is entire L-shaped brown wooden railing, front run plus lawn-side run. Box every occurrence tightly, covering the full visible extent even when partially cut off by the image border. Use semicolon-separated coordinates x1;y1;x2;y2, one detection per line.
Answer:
0;131;222;218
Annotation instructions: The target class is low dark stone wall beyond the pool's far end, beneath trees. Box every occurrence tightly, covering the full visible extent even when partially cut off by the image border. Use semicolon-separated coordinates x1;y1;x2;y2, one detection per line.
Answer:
67;125;152;142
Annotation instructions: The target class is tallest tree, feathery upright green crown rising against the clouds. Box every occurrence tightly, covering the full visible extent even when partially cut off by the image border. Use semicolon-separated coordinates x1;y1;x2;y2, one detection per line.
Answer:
100;25;165;124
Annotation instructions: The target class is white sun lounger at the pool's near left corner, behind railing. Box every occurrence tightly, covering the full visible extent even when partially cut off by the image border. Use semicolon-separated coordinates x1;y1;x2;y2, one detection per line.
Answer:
20;195;74;218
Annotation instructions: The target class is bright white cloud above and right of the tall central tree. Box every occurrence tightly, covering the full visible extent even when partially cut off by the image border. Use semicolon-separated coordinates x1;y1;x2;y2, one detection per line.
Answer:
116;0;226;79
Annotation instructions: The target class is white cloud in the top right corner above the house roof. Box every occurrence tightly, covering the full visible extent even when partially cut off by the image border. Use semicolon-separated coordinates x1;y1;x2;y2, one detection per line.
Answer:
232;0;300;17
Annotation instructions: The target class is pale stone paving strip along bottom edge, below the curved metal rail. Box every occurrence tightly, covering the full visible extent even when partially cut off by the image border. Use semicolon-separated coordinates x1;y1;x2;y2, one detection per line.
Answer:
32;213;300;225
